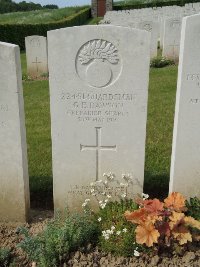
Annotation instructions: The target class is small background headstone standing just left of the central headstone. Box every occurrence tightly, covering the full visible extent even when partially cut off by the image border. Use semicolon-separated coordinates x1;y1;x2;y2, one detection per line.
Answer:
25;35;48;77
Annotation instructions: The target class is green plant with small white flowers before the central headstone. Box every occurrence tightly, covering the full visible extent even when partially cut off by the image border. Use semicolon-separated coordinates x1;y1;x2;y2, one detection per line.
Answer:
82;173;144;256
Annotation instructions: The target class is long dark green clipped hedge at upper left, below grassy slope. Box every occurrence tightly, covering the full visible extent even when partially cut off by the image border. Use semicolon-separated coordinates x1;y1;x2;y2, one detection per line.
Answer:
0;8;91;50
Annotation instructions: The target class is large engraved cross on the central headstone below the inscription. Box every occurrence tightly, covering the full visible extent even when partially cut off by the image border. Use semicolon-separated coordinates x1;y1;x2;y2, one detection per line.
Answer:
80;127;117;181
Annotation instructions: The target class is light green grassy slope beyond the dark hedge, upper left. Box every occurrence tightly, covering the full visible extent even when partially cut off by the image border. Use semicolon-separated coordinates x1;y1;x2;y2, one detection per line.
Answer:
0;6;88;24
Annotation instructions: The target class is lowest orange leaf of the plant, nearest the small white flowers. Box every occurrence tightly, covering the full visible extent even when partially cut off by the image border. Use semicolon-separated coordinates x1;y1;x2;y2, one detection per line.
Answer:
135;221;160;247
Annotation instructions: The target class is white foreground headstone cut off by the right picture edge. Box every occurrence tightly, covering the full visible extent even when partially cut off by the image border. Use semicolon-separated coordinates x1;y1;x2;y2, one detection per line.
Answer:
169;15;200;197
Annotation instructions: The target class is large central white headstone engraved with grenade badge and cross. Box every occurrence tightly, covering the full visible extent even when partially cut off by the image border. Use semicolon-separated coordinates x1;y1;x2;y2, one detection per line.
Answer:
48;25;150;214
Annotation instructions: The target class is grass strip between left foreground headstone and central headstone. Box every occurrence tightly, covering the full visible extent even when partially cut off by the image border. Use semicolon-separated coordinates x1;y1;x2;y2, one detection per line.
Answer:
23;81;53;207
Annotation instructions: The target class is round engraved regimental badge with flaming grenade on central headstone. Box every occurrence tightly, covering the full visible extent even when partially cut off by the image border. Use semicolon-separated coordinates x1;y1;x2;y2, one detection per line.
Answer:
76;39;122;88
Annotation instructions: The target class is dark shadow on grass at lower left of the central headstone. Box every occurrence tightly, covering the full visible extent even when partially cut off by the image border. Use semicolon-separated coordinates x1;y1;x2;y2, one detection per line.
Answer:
30;176;53;210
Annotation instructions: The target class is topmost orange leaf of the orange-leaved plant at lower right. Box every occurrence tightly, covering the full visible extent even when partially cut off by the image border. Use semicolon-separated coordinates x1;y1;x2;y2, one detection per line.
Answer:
164;192;186;211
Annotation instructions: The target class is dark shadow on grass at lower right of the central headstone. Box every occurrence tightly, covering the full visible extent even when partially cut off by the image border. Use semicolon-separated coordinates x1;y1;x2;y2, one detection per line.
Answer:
144;172;169;200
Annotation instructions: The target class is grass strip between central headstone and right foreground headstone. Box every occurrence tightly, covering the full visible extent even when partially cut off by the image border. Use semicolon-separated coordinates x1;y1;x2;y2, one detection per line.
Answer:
144;66;177;197
